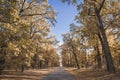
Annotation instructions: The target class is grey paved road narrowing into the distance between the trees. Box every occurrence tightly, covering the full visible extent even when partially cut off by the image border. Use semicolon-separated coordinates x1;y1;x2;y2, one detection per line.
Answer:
40;68;76;80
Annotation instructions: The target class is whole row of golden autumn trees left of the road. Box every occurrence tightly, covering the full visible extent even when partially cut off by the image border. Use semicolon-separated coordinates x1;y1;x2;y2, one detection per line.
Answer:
0;0;59;74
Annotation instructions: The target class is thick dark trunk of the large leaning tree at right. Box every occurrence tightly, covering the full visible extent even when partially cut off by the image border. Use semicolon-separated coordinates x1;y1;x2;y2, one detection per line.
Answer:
97;14;115;73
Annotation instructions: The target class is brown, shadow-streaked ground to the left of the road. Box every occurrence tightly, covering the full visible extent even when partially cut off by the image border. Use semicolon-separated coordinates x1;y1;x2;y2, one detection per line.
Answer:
0;69;55;80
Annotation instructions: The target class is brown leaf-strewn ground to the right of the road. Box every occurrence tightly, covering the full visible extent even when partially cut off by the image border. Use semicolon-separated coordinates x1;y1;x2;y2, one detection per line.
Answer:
67;68;120;80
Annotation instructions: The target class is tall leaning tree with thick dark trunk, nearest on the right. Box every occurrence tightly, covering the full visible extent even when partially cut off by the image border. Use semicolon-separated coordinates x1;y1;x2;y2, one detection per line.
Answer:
62;0;120;73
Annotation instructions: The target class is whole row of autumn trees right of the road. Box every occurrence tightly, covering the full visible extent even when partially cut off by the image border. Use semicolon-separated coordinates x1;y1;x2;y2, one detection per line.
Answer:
62;0;120;73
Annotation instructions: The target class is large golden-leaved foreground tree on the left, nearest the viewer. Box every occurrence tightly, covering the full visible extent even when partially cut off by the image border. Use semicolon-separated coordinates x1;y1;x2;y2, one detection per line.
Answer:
0;0;56;73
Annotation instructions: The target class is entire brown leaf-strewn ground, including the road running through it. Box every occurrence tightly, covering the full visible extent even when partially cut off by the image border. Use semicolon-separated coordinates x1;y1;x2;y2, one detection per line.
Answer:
0;68;120;80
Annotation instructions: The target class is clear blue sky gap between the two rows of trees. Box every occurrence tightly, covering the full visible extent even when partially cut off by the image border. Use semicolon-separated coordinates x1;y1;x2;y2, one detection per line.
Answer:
49;0;77;44
